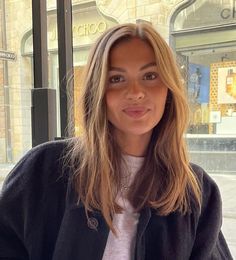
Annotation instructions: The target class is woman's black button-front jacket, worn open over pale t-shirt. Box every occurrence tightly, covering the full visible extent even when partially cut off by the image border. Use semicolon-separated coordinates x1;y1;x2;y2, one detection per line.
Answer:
0;141;232;260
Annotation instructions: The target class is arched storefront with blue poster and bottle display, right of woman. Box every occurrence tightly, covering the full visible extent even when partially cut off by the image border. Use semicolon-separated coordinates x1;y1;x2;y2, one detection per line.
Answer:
171;0;236;173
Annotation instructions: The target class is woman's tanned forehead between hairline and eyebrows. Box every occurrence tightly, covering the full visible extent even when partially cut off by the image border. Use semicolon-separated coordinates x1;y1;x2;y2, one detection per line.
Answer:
109;37;155;63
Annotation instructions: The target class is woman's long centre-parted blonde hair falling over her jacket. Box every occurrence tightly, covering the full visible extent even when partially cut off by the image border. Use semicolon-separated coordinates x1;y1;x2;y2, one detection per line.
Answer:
69;23;201;232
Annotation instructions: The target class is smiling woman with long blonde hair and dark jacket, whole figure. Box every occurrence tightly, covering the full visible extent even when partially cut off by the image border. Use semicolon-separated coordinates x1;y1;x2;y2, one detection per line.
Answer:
0;24;232;260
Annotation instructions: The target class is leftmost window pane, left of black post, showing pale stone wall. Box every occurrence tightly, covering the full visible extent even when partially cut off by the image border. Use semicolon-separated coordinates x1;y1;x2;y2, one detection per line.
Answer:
0;0;33;171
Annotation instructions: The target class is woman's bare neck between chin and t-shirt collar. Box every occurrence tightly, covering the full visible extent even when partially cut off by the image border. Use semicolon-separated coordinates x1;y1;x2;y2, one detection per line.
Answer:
116;133;151;157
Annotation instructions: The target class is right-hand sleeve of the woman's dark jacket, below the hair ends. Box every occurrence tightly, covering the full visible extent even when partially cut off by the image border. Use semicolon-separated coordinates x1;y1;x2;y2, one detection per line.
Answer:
190;167;233;260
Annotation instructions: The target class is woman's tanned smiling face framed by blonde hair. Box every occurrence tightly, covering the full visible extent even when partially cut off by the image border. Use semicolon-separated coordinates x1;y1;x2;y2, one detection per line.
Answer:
105;38;167;141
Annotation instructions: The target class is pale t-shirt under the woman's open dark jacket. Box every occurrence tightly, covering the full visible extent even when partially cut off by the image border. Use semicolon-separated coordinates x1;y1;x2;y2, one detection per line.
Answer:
102;155;144;260
